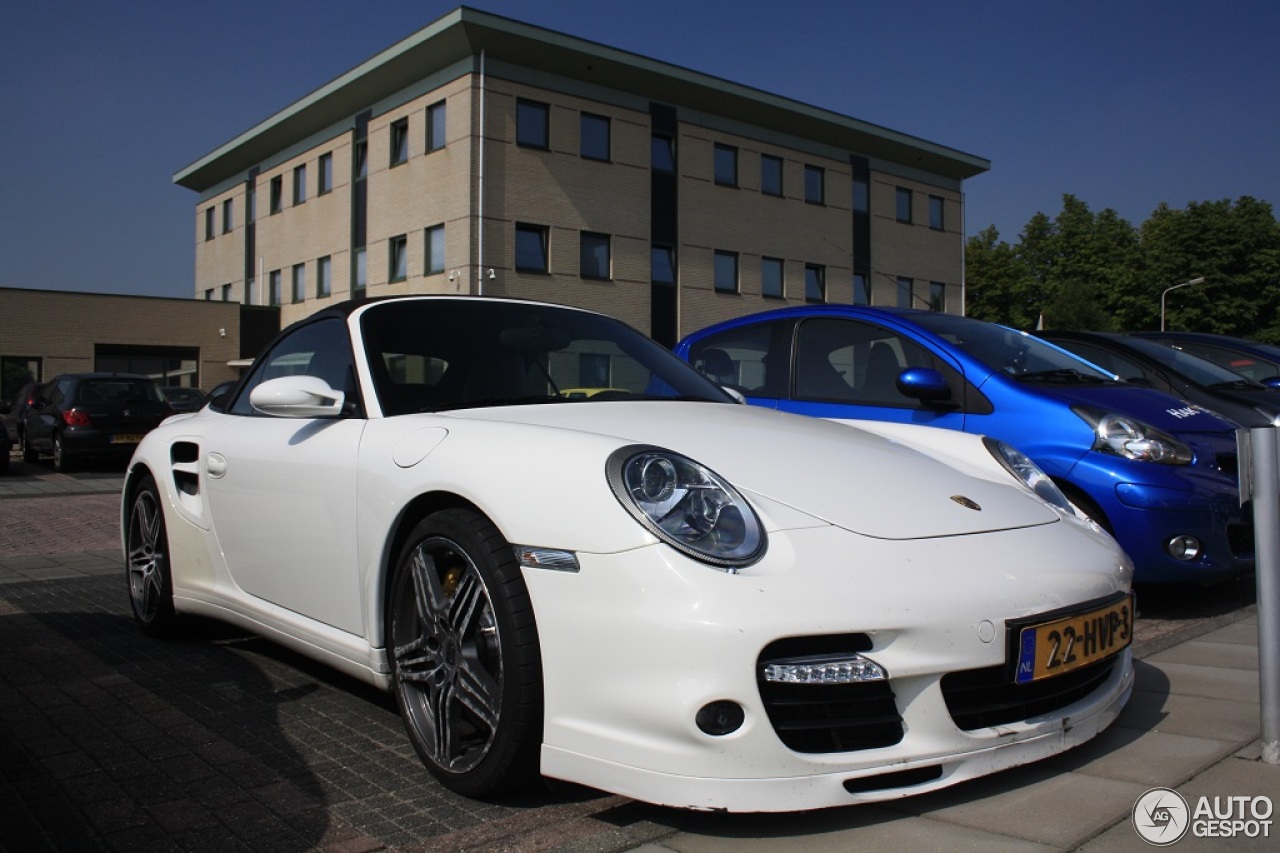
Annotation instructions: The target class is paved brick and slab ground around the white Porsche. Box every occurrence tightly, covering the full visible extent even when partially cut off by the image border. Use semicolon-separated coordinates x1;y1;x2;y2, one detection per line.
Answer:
0;448;1280;853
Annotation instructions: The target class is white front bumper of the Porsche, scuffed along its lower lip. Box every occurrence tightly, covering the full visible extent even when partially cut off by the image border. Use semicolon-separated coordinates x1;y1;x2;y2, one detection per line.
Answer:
525;521;1133;811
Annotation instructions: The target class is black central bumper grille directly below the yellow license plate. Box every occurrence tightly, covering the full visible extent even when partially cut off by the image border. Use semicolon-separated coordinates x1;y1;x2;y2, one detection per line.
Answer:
942;657;1119;731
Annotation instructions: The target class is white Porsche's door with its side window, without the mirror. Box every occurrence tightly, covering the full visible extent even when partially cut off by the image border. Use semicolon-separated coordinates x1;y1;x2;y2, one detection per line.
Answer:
201;319;365;635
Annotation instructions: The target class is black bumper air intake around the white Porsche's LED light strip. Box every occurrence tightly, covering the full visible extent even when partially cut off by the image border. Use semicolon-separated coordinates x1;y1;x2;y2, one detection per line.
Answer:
756;634;902;753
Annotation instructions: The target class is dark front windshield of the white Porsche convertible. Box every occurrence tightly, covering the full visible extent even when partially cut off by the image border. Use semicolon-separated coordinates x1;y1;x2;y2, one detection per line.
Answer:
360;298;732;415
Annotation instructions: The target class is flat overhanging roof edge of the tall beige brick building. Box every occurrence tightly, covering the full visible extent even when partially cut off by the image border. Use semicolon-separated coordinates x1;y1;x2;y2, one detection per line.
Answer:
173;6;991;192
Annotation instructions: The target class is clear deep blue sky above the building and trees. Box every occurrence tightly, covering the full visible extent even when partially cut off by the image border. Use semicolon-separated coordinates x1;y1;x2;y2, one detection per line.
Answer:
0;0;1280;297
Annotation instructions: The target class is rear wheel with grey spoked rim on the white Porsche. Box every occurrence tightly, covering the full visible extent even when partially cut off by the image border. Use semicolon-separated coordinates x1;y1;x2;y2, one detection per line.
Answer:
124;475;178;637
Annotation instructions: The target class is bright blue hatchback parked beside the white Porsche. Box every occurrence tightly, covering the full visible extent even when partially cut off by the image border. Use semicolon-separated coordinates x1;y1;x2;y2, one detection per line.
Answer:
676;305;1253;583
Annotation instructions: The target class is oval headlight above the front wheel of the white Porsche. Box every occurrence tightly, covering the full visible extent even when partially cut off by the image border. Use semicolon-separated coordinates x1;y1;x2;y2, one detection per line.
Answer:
605;446;764;571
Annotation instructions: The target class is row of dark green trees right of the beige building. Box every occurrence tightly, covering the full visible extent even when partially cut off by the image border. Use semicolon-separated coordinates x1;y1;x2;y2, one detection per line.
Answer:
965;195;1280;342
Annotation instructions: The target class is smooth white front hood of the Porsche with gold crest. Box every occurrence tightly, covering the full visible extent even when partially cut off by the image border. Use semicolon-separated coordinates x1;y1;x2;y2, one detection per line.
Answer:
452;401;1060;539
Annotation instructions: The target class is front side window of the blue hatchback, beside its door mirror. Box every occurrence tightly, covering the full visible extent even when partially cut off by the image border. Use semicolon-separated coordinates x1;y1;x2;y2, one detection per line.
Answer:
795;318;964;409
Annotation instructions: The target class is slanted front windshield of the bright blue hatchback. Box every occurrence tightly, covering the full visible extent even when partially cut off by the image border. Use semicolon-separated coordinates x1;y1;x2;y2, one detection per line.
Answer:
910;311;1119;384
